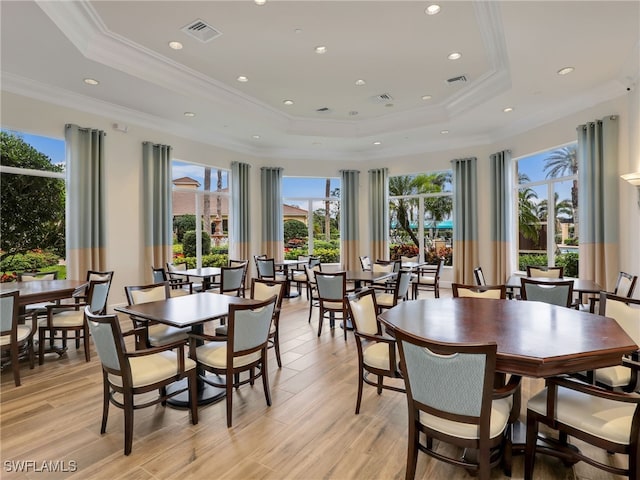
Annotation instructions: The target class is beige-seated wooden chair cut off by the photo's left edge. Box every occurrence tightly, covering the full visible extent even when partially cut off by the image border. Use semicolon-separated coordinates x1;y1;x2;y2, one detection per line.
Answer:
0;290;38;387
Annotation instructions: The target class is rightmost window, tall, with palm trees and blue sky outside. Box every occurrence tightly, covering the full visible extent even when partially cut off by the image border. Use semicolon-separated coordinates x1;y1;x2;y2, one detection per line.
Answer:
516;143;579;277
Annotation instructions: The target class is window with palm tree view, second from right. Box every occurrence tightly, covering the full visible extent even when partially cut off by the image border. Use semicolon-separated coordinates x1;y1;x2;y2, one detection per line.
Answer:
389;171;454;265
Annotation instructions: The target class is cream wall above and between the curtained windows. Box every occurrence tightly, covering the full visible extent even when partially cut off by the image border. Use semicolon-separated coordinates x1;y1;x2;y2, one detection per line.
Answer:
0;91;640;305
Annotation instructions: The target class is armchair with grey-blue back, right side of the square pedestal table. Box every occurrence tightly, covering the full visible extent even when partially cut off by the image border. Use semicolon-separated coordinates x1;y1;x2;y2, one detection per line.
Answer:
189;295;277;428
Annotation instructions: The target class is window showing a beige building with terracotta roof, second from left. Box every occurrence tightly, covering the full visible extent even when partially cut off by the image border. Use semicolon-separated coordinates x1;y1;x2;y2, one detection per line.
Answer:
171;160;230;268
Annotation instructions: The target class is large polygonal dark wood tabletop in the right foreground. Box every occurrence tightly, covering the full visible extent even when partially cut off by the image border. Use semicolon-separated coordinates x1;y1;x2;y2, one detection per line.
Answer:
378;298;638;377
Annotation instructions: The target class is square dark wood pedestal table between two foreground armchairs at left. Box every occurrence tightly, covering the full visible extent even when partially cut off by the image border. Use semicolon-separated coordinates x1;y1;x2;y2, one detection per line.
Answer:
114;292;259;408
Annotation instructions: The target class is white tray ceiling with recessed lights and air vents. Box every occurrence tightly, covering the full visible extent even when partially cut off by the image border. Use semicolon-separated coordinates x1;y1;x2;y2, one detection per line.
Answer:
0;0;640;161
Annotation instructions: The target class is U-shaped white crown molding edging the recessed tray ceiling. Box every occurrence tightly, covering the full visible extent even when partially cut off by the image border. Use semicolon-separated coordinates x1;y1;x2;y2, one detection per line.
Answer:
37;0;511;141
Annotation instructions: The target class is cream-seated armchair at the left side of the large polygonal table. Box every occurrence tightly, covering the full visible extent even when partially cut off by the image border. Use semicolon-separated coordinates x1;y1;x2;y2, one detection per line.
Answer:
348;288;405;415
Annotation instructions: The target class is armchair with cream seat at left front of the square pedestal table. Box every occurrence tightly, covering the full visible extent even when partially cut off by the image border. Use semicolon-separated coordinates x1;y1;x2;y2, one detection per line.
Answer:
83;307;198;455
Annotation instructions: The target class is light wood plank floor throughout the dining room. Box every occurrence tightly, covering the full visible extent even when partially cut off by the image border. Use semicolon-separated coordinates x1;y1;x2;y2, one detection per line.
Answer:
0;291;624;480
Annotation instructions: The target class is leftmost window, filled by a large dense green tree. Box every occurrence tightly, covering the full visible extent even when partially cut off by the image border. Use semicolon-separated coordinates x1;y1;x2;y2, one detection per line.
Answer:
0;130;66;281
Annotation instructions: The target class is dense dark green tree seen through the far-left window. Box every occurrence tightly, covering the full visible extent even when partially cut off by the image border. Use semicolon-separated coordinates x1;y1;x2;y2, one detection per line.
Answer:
0;132;65;256
